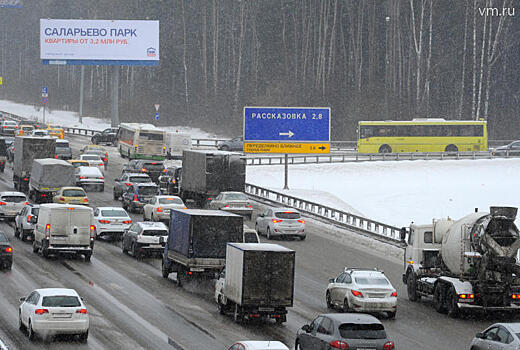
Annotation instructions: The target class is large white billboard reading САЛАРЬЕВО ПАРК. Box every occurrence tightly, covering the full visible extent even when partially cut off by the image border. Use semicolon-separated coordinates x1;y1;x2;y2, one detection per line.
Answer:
40;19;159;65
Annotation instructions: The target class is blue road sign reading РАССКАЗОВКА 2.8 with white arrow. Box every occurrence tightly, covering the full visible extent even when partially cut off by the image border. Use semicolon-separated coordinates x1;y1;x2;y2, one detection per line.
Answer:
244;107;330;142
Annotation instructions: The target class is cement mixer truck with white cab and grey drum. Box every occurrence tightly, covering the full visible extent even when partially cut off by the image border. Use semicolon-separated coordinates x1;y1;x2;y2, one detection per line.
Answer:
401;207;520;317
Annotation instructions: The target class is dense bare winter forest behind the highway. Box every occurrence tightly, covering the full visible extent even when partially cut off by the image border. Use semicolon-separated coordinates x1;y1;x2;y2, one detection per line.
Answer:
0;0;520;140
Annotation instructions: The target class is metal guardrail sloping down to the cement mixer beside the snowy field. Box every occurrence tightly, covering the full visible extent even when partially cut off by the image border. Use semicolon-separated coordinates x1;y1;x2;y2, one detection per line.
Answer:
245;183;401;247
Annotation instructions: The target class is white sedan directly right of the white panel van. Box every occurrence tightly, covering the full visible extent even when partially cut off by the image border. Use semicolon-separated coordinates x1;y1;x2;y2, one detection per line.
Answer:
94;207;132;240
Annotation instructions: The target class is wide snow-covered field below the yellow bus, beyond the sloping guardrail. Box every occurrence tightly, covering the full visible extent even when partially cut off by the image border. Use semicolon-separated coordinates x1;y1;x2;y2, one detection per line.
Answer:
247;159;520;227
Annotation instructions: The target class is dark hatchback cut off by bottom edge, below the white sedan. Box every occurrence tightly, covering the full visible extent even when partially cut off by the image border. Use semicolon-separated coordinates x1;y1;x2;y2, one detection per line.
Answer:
295;313;395;350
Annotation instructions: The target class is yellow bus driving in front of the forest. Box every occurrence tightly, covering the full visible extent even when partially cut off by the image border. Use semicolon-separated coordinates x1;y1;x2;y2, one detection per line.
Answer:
357;118;488;153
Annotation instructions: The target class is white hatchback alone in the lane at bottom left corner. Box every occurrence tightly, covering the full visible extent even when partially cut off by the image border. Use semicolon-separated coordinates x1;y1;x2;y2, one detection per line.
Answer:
18;288;89;342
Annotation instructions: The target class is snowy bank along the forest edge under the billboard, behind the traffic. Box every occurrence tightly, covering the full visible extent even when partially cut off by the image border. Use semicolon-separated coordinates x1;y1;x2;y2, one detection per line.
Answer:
0;100;223;139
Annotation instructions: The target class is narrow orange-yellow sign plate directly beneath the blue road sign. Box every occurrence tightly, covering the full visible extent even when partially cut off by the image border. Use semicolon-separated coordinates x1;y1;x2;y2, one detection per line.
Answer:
244;142;330;153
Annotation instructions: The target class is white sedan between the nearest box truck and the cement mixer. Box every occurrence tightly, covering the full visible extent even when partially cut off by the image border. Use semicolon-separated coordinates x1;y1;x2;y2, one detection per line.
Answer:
326;267;397;318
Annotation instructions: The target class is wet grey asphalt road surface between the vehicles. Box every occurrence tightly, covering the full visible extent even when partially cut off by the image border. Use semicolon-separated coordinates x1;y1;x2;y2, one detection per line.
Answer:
0;133;512;349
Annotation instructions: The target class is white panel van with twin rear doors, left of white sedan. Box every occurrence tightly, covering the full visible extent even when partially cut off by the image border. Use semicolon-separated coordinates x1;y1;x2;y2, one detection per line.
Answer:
31;203;96;261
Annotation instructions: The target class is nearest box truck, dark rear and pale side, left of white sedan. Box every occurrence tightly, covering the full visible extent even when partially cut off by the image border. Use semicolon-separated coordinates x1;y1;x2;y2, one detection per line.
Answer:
215;243;295;323
